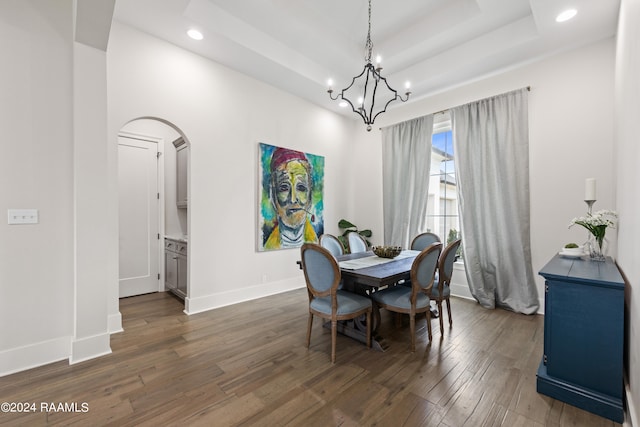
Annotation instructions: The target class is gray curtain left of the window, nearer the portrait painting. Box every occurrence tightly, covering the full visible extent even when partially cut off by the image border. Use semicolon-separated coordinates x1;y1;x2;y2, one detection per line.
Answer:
382;114;433;248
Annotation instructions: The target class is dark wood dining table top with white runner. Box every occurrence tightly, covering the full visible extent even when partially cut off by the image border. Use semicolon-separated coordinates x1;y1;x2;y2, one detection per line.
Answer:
338;251;419;288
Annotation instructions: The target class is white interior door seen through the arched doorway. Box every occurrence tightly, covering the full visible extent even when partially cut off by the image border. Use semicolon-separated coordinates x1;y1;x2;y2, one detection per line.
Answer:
118;136;160;298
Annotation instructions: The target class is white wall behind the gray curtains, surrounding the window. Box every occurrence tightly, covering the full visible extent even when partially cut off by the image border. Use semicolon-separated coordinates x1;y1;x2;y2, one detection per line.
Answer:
357;39;616;311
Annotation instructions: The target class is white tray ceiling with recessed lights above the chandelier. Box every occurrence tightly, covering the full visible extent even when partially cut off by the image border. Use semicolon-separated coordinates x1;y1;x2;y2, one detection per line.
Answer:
114;0;620;119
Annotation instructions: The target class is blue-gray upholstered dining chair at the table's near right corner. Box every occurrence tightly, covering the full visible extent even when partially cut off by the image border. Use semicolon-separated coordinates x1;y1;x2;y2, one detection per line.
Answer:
372;242;442;351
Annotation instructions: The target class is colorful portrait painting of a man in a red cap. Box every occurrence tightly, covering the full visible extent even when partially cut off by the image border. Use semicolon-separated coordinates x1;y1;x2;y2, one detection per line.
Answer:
258;143;324;251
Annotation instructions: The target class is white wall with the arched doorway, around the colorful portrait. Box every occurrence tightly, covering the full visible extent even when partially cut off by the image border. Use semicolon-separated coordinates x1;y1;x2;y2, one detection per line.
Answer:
107;24;354;313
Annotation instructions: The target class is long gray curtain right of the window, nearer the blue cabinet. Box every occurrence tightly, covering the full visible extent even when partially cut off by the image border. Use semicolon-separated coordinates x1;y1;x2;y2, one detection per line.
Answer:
451;89;538;314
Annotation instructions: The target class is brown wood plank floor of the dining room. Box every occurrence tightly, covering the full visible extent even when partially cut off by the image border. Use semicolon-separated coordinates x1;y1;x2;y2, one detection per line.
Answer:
0;289;619;427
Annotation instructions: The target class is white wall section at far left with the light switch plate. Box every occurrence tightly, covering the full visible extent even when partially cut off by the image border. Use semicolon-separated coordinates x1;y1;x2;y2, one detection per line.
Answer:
0;0;74;375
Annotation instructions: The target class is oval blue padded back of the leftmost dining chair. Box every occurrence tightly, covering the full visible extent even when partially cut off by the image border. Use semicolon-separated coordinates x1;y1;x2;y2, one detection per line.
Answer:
300;243;340;300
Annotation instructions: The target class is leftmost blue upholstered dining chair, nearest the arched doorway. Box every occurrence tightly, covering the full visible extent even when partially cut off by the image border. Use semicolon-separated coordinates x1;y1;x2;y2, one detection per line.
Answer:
300;243;373;363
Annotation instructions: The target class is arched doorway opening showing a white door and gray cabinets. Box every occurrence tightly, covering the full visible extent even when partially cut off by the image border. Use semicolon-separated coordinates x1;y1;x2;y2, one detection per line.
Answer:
118;118;189;299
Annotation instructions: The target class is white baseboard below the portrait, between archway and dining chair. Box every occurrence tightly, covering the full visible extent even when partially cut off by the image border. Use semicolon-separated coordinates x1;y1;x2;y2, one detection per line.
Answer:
184;277;306;315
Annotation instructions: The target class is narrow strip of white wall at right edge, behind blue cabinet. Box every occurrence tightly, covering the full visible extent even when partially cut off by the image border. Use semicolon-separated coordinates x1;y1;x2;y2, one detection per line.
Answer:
614;0;640;426
